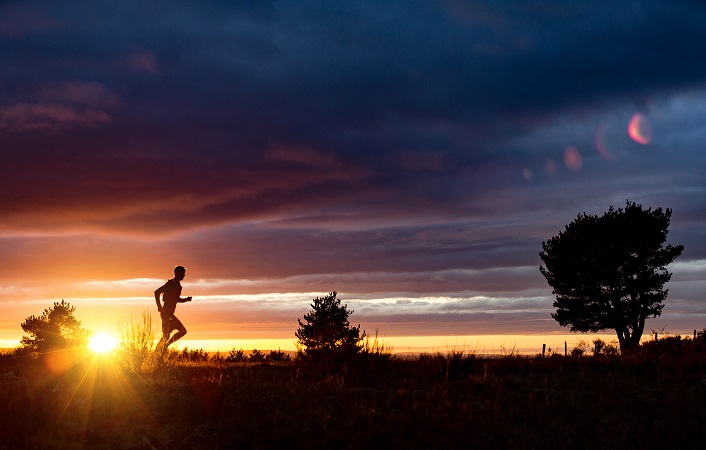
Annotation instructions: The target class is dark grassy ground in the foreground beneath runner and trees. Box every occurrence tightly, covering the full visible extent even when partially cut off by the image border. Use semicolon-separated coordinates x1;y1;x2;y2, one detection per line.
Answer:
0;335;706;450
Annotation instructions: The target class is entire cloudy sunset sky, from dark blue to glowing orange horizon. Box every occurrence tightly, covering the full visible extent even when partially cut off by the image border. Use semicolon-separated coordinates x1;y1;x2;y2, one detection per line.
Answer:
0;0;706;351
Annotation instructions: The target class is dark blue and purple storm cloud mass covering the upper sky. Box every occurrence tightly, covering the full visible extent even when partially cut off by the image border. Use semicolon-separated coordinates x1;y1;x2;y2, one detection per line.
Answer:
0;2;706;232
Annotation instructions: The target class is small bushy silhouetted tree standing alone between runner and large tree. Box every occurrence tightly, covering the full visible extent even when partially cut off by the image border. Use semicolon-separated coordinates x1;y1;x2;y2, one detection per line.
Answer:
294;292;365;355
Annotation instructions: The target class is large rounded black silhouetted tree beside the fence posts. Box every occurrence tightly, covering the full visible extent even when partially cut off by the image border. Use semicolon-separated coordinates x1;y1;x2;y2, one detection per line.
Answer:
539;201;684;352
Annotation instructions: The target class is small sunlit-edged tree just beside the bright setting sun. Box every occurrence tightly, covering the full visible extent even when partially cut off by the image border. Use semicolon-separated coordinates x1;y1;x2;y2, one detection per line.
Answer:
20;299;88;353
